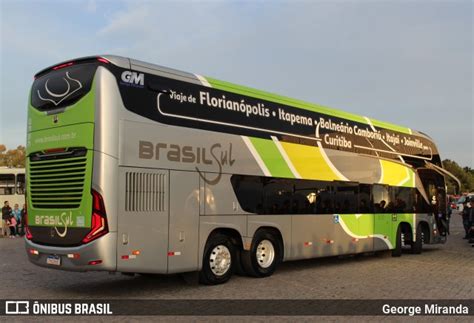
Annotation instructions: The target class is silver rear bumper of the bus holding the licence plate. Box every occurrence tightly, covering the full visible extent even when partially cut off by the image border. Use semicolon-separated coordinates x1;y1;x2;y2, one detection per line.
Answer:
25;232;117;271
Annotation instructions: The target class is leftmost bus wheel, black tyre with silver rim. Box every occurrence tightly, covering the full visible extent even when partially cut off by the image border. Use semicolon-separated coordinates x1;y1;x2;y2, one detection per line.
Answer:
199;234;237;285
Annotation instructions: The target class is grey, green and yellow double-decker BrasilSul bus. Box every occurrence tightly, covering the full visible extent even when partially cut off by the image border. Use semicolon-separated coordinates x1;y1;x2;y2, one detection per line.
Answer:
26;56;458;284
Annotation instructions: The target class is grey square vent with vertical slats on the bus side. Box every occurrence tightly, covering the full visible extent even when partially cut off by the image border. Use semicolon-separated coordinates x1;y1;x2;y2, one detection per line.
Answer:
125;172;166;212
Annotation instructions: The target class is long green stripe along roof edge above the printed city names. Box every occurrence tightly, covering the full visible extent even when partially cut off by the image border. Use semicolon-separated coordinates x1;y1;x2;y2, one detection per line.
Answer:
205;76;411;134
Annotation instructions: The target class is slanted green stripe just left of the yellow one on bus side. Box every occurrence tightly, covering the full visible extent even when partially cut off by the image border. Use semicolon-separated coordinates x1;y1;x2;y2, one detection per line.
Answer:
249;137;294;178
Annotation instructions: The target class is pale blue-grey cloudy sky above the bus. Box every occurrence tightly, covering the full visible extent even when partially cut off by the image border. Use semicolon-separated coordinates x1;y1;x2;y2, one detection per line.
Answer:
0;0;474;168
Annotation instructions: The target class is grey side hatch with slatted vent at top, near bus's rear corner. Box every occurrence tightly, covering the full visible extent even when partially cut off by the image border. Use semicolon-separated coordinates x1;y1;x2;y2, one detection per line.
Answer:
117;167;169;273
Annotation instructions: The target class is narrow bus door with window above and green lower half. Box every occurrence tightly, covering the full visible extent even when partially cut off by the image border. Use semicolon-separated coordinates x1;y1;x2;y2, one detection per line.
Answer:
372;184;397;250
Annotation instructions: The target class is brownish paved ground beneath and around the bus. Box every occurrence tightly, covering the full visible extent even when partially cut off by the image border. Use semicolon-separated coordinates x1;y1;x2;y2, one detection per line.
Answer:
0;213;474;320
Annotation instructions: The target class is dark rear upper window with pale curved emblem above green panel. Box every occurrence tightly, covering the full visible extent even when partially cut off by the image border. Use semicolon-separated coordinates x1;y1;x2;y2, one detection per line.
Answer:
31;63;98;111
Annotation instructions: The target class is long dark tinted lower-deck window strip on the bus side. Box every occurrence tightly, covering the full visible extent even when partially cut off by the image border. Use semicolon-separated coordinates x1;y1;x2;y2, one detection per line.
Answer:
231;175;430;214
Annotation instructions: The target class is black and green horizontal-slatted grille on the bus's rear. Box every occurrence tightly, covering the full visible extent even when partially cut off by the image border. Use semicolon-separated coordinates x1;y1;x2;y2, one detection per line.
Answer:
28;155;87;209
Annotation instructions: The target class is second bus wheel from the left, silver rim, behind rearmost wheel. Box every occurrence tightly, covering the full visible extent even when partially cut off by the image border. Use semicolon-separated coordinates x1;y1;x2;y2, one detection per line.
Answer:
241;231;283;277
